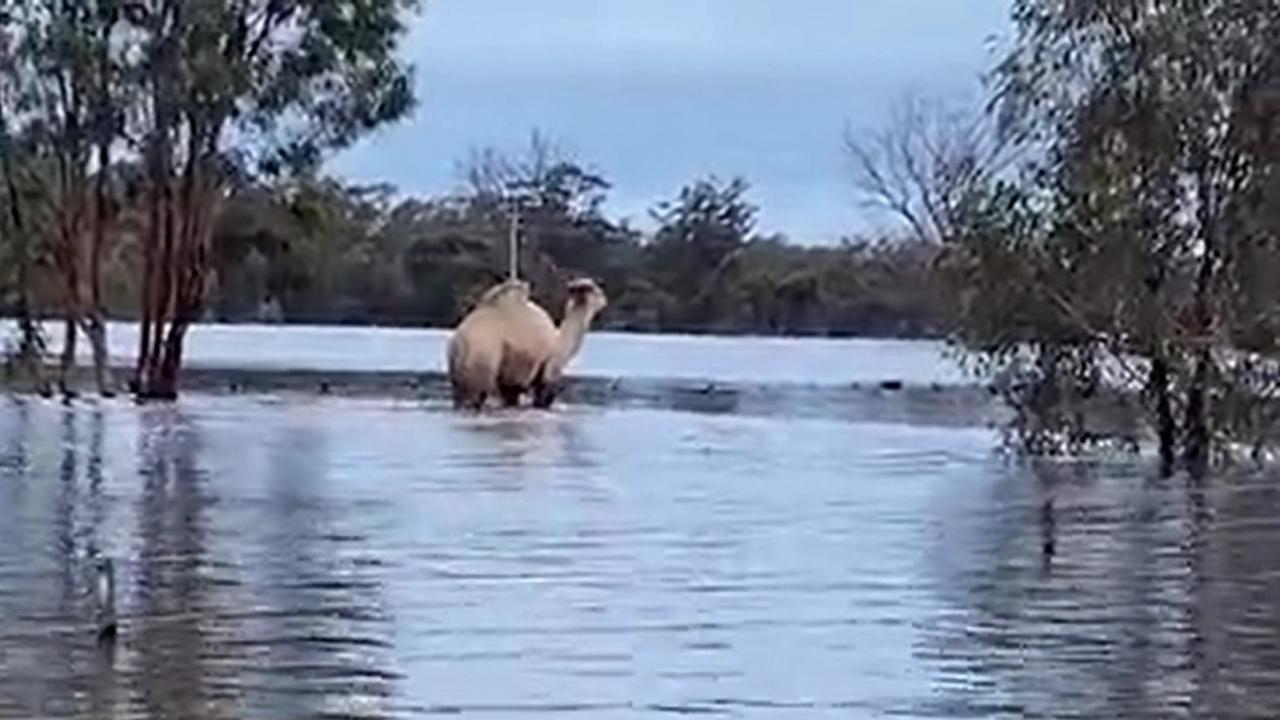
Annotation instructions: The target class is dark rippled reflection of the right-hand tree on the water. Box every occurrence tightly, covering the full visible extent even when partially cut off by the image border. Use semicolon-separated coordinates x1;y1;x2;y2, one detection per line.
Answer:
922;465;1280;717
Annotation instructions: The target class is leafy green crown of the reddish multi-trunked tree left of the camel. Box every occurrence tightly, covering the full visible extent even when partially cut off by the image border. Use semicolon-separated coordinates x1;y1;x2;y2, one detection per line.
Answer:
116;0;419;174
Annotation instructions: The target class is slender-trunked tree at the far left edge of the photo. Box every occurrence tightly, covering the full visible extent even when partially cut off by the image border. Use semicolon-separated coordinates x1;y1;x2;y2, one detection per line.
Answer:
4;0;124;395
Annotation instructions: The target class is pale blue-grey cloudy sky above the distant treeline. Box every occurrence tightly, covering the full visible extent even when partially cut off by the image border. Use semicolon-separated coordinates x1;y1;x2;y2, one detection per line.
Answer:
329;0;1009;243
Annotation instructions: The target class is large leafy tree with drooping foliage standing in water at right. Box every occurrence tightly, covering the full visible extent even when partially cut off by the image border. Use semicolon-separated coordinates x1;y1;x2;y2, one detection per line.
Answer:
921;0;1280;469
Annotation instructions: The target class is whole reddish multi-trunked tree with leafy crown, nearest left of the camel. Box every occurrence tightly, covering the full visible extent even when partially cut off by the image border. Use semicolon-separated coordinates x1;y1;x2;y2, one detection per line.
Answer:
124;0;417;398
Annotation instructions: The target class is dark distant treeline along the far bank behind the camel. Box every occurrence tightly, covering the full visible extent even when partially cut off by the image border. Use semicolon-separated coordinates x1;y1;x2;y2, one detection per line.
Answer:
6;133;943;337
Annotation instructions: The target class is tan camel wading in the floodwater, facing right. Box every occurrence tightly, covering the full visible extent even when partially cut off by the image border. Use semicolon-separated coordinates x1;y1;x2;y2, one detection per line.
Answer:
448;278;608;410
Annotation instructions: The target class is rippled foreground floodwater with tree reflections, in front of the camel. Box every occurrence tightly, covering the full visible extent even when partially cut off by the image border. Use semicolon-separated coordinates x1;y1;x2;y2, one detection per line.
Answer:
0;397;1280;719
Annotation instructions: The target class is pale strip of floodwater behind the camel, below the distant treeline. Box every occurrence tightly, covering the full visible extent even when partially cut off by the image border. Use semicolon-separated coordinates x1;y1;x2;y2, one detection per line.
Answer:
0;322;970;384
